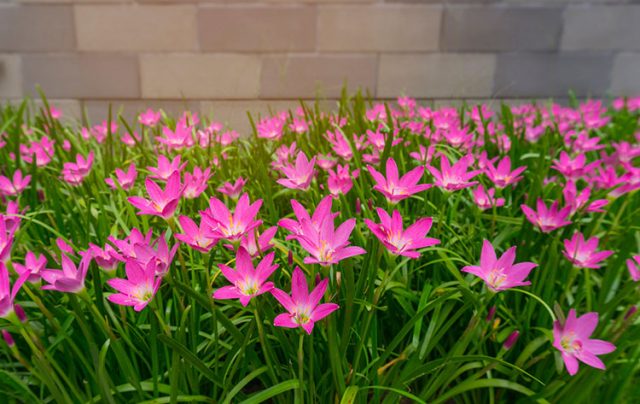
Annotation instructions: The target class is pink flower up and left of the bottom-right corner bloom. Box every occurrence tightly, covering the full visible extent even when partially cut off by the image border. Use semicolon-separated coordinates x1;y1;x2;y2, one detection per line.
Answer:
462;240;538;292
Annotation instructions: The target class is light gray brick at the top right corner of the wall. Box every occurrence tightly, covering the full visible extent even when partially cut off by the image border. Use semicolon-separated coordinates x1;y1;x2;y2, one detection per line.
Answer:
561;5;640;50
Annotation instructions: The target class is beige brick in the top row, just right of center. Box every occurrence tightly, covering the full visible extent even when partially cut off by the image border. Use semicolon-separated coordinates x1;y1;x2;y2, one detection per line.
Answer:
318;5;442;52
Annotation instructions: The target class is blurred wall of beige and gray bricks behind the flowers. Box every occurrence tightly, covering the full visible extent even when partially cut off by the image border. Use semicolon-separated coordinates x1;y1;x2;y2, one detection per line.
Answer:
0;0;640;129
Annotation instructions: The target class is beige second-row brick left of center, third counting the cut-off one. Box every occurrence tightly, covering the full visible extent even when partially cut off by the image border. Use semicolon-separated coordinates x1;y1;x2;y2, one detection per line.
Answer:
140;54;261;99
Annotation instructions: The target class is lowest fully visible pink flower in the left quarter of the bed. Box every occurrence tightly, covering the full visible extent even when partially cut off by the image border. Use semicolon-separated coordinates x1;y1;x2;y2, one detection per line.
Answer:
107;260;162;311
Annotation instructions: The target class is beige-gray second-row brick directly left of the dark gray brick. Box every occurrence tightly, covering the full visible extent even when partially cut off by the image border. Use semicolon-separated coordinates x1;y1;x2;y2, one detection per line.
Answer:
378;53;496;98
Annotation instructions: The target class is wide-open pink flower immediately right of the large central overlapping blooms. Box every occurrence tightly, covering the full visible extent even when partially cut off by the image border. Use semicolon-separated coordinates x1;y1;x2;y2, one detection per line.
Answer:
364;208;440;258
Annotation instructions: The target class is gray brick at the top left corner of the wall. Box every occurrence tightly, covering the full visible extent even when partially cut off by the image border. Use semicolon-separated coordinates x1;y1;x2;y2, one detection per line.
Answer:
0;4;75;52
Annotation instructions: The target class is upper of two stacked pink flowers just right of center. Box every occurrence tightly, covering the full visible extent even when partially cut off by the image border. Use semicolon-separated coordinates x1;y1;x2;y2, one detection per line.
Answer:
367;157;431;203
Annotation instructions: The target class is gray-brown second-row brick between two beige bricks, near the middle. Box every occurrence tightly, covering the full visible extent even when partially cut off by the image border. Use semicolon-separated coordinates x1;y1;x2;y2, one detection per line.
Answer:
260;55;377;98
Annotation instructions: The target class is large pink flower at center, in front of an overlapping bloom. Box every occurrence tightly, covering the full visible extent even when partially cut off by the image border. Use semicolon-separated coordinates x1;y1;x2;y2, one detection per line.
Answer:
296;212;366;266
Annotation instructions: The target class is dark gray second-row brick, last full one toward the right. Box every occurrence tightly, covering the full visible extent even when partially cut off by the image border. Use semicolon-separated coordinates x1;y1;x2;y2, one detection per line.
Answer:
494;53;613;97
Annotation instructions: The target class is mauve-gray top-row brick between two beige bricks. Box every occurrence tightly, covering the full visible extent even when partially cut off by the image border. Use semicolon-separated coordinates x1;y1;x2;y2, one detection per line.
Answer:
198;5;316;52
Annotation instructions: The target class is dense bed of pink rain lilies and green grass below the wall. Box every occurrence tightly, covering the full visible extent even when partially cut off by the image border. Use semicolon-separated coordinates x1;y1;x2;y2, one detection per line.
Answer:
0;95;640;403
